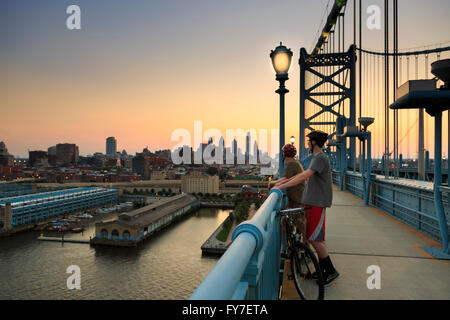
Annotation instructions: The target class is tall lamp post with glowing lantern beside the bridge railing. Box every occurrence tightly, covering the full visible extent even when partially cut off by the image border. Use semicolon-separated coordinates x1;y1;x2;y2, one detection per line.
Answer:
270;42;292;178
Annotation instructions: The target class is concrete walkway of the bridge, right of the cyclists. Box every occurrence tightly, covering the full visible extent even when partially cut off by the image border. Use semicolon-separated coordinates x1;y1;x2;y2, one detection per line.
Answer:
282;188;450;300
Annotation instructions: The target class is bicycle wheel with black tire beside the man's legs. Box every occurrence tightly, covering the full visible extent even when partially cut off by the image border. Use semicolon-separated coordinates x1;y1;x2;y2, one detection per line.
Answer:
291;242;324;300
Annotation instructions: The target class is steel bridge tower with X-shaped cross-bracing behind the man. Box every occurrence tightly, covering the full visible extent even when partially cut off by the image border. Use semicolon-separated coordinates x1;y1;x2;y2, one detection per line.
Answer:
299;45;356;167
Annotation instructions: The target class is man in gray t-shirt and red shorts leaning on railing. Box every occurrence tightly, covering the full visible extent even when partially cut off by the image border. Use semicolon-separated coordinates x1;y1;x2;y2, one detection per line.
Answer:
275;130;339;285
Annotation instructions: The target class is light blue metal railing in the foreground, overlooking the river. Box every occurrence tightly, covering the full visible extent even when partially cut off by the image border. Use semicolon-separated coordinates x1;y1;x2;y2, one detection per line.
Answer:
190;190;283;300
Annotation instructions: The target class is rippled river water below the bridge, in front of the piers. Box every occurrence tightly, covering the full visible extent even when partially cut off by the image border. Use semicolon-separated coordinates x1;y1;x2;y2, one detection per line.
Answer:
0;208;230;300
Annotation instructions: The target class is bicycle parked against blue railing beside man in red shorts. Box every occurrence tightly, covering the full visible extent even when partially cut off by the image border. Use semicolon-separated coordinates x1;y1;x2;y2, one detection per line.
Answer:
277;207;324;300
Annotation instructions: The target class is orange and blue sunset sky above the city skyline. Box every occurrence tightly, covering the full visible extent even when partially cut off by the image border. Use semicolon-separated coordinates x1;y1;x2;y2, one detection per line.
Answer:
0;0;450;157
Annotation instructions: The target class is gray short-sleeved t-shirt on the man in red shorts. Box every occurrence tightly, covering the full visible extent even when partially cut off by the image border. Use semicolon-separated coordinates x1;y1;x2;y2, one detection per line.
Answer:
303;152;333;208
